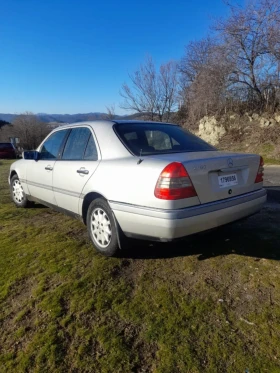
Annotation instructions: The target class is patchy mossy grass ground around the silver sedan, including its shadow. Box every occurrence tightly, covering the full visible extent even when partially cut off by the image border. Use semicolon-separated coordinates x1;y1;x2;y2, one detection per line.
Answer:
0;161;280;373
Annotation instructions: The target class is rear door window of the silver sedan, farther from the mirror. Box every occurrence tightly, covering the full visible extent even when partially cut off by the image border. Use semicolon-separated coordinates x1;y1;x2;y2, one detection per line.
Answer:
62;127;98;160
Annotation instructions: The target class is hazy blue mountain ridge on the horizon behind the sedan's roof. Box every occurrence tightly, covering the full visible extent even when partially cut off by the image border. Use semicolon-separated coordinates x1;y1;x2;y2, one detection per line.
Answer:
0;112;144;123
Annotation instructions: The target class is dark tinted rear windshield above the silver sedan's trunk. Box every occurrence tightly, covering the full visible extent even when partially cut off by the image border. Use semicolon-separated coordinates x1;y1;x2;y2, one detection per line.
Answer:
114;123;216;156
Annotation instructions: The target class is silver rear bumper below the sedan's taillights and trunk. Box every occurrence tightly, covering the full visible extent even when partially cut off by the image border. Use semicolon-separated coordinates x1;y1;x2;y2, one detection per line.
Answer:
110;189;266;241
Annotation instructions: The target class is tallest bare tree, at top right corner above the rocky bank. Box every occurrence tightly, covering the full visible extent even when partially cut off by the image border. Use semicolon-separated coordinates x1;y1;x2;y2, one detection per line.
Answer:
215;0;280;109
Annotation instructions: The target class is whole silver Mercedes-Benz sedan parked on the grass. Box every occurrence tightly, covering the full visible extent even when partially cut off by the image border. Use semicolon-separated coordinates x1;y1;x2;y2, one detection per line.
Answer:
9;120;266;256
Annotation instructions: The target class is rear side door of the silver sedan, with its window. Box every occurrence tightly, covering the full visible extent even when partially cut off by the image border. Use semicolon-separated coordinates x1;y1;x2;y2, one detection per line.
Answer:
53;127;100;214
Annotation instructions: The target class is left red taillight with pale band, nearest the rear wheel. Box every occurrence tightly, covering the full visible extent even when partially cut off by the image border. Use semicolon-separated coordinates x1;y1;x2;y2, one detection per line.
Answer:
155;162;197;200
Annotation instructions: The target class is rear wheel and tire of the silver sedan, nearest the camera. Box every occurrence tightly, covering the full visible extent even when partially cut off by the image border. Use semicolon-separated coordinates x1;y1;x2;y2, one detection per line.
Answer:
87;198;119;256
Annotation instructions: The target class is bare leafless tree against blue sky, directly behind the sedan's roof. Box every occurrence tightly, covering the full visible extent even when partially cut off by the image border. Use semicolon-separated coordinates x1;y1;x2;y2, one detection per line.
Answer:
120;57;178;121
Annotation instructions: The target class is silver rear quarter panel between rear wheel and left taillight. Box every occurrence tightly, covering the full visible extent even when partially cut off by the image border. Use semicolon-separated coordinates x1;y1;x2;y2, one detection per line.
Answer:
82;156;199;209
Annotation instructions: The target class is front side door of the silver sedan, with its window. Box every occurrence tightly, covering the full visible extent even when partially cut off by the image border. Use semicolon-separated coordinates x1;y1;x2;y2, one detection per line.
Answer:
26;130;68;205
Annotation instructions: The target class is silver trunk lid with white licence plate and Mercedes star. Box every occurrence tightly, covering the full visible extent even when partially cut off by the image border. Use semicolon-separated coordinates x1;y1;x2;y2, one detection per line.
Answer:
150;151;262;204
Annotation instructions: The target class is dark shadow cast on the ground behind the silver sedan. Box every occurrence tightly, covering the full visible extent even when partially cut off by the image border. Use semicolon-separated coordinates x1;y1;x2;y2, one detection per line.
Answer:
119;205;280;260
